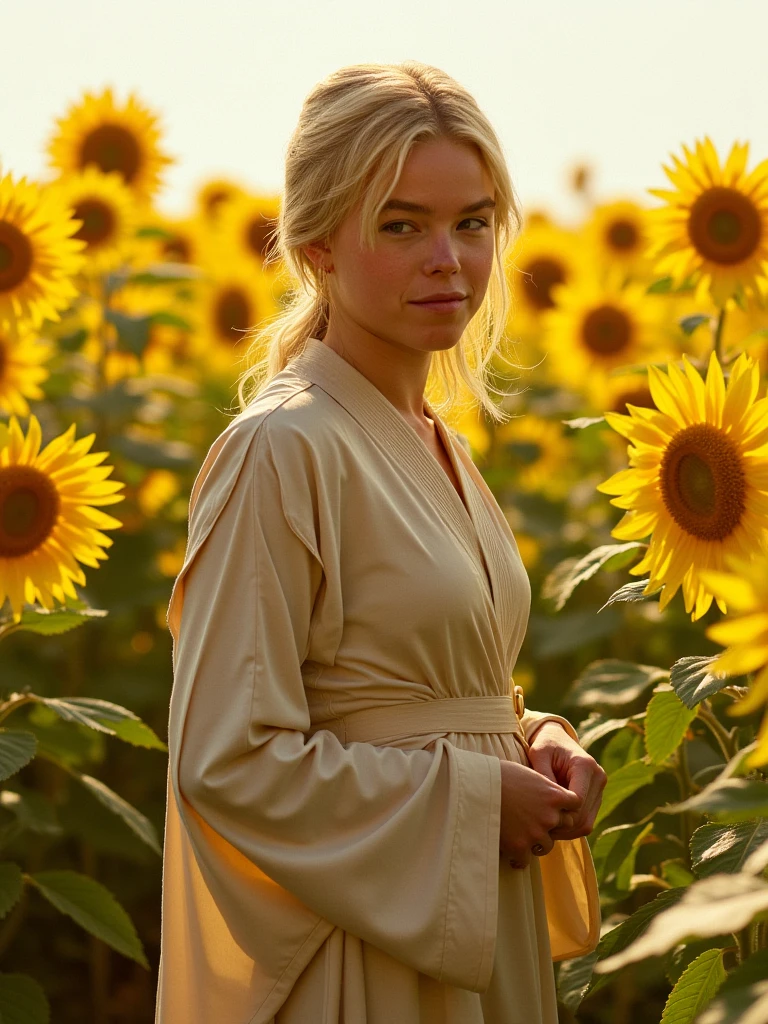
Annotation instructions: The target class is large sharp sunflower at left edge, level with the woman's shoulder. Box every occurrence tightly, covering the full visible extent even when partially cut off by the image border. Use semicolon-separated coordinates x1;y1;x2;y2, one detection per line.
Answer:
0;416;125;622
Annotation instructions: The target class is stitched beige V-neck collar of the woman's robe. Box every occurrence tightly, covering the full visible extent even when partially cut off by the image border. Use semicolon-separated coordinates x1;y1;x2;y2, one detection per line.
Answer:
287;338;501;614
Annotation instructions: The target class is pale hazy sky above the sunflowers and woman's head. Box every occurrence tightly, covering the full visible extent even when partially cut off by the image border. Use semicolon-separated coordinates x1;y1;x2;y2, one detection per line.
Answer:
6;0;768;222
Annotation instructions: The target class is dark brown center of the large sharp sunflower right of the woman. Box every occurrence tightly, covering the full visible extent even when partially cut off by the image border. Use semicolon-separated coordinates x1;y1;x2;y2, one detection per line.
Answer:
659;423;746;541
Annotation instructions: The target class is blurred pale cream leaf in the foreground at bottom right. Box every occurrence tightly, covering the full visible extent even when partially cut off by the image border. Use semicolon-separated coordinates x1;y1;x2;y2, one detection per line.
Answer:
595;874;768;974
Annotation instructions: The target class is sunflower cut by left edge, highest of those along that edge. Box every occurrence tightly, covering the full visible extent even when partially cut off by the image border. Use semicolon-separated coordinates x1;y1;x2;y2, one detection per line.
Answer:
0;174;85;337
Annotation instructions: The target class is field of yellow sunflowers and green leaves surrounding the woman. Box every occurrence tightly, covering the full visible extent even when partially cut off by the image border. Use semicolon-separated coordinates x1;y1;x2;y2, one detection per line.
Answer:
0;89;768;1024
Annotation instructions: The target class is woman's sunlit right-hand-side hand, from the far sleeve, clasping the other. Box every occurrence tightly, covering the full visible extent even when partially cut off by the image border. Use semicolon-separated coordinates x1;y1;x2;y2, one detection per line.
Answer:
527;721;608;840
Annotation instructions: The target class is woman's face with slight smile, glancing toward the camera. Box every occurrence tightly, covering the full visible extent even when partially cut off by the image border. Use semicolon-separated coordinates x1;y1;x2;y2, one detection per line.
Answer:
313;138;495;360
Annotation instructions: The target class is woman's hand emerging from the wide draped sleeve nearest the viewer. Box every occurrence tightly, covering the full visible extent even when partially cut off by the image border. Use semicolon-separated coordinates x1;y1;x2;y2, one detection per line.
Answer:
499;761;582;867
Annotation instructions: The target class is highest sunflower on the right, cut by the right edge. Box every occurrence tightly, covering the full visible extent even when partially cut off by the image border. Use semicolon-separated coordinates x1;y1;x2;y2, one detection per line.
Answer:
648;136;768;307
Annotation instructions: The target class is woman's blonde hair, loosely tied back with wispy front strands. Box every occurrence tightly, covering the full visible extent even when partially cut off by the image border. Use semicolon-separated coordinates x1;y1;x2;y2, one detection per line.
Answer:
231;60;522;422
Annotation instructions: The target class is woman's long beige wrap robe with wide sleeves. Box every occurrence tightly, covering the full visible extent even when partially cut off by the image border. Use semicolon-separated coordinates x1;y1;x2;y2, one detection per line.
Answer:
156;339;600;1024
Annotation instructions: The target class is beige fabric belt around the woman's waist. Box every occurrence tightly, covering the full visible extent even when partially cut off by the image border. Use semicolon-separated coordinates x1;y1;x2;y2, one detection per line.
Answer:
307;686;525;743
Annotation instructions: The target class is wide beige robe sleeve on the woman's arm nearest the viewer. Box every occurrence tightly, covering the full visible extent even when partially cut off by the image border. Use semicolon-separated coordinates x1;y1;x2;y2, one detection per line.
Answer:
169;416;501;991
